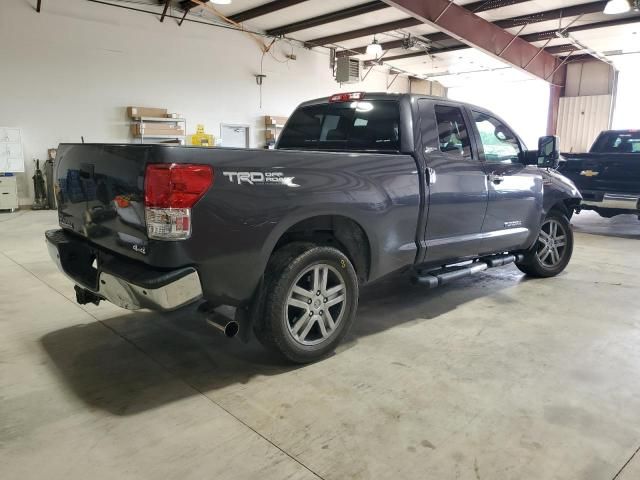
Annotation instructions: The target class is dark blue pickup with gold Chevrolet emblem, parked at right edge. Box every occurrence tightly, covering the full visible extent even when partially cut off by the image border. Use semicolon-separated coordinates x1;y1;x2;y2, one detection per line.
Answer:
559;130;640;217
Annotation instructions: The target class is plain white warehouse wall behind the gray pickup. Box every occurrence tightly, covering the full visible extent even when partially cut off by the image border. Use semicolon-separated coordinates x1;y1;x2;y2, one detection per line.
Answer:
0;0;409;204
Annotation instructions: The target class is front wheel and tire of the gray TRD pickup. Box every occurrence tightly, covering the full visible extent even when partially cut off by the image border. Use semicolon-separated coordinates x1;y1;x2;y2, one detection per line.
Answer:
516;210;573;278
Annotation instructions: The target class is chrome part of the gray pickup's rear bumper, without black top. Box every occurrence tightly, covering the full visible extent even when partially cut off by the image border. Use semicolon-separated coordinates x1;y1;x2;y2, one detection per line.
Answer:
47;233;202;311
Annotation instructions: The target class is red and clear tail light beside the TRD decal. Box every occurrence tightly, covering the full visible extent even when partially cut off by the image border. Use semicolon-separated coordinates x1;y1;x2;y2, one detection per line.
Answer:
144;163;213;240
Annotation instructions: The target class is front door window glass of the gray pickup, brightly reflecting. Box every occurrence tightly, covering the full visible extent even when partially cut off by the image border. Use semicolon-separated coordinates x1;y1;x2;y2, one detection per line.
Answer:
473;112;521;163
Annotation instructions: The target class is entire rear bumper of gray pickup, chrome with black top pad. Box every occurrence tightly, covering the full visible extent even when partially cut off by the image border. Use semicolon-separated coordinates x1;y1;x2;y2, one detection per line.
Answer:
45;230;202;311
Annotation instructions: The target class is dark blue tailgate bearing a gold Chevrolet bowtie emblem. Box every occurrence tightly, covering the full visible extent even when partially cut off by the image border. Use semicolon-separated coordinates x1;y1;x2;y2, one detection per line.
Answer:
559;153;640;198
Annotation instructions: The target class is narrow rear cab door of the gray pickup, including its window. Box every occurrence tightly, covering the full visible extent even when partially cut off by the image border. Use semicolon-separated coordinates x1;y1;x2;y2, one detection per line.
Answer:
418;99;488;263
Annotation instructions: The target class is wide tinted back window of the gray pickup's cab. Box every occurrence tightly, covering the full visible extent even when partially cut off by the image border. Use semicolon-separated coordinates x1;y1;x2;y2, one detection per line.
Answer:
278;100;400;152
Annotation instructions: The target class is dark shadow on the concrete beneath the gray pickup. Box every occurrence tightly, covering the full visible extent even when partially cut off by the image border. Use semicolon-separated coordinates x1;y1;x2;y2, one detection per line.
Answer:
41;267;524;415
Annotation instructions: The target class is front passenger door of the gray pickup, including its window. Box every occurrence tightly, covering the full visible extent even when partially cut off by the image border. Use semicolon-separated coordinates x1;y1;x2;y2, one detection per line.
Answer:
471;110;543;253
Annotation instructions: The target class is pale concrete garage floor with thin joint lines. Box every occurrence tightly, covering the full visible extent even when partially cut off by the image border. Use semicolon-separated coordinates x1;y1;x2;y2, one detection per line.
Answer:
0;212;640;480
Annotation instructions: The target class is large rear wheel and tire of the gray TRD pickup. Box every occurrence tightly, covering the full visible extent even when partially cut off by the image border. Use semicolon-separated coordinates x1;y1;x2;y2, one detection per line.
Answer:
255;243;358;363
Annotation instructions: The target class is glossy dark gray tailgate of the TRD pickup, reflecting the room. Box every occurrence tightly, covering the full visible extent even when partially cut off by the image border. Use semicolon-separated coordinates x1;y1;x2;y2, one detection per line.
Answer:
54;144;153;260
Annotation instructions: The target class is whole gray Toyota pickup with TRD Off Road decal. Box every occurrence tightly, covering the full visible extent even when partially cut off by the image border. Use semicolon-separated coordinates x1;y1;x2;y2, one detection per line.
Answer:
46;93;580;362
